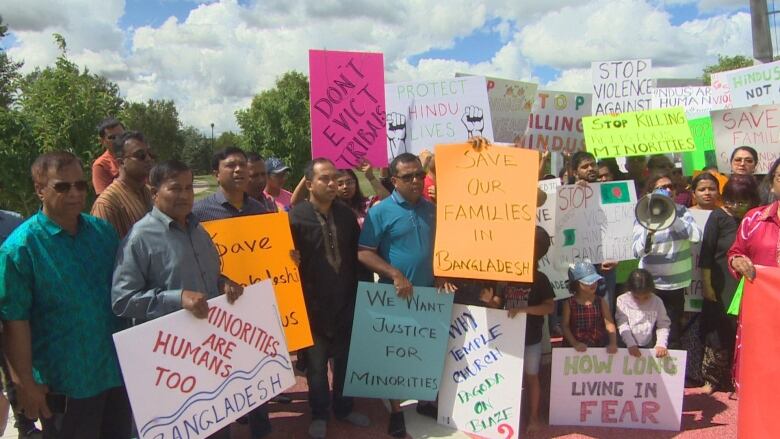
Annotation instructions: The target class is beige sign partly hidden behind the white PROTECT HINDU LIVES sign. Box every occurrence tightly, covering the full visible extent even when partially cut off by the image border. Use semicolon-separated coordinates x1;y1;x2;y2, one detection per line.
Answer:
455;73;538;143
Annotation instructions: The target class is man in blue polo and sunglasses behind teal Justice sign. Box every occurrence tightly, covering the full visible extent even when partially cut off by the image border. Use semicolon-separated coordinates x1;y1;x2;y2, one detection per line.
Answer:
358;153;436;437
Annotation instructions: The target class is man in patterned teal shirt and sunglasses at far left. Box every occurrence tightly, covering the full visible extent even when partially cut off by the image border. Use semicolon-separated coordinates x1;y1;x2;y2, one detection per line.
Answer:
0;152;131;439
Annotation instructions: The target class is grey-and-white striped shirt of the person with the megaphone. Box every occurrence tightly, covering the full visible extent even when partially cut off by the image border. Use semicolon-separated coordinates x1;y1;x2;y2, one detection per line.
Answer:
632;206;702;291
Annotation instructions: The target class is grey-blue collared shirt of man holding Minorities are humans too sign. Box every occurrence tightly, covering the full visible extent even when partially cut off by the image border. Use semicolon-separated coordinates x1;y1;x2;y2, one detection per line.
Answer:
111;207;221;322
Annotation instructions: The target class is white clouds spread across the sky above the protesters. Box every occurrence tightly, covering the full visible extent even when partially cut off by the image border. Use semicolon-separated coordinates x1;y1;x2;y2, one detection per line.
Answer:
2;0;751;132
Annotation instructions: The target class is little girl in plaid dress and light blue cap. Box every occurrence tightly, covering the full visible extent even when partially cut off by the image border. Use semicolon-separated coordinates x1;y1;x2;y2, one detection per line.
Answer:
562;262;617;354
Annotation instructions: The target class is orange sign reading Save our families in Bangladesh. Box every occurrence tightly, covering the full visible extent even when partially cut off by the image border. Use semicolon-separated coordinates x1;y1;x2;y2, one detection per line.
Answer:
433;144;539;282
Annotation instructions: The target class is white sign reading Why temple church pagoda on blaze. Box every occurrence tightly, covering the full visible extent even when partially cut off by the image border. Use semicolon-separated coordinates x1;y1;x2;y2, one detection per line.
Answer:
439;305;526;438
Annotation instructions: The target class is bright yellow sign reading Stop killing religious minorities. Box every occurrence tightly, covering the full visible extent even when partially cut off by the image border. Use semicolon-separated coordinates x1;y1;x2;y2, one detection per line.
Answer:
582;107;696;159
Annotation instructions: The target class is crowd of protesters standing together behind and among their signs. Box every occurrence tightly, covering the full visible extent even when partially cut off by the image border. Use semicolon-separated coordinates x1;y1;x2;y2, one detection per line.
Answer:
0;118;780;439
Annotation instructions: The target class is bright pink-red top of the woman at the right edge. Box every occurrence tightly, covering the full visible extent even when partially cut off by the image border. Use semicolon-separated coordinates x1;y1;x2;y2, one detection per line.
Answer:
728;201;780;278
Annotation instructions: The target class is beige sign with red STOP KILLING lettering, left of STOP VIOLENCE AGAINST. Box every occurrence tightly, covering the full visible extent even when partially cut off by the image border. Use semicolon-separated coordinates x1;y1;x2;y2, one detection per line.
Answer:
516;90;591;154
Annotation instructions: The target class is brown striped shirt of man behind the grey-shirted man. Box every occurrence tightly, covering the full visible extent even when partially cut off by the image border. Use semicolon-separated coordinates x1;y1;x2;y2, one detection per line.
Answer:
90;179;152;239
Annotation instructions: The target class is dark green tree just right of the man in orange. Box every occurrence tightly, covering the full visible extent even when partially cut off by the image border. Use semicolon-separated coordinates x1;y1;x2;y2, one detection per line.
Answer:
119;99;184;161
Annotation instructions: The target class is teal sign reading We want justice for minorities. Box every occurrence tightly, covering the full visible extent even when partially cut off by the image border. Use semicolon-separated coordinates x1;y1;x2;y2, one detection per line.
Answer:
344;282;454;401
